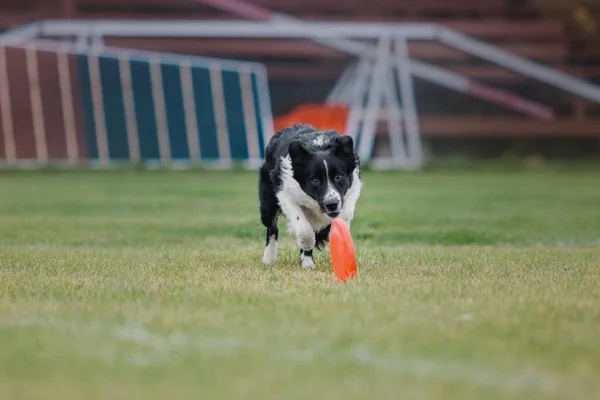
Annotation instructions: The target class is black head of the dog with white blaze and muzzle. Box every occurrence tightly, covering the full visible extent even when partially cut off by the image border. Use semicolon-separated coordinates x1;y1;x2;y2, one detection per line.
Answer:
289;136;356;218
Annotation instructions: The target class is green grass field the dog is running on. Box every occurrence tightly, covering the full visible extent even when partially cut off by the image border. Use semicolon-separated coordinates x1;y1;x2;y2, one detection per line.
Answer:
0;164;600;400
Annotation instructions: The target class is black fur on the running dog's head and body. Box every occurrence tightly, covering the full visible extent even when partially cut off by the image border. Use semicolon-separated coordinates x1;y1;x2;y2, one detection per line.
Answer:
258;124;360;268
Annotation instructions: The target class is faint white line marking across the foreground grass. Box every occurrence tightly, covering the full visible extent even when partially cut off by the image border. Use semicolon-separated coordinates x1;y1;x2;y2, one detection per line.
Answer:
0;316;564;395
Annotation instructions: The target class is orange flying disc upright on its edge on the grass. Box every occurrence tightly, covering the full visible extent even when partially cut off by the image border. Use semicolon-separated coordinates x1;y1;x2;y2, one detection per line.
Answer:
329;218;358;282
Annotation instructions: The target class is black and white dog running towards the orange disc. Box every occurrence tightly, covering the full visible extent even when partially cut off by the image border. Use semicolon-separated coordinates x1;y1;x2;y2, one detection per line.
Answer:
258;124;362;268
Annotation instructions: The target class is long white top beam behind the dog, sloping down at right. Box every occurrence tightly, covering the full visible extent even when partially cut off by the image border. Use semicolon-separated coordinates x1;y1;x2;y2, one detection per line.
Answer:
28;20;600;103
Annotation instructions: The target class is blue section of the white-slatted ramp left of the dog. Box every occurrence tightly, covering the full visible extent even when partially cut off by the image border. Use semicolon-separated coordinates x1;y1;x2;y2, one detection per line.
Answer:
81;48;272;164
